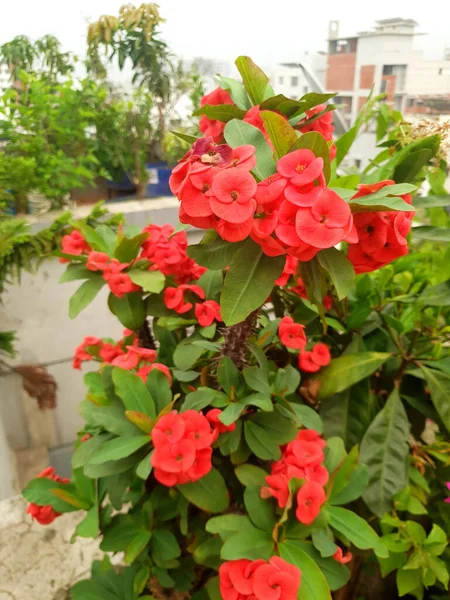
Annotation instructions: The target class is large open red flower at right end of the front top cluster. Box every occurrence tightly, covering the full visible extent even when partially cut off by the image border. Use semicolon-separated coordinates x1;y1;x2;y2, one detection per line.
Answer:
295;189;353;248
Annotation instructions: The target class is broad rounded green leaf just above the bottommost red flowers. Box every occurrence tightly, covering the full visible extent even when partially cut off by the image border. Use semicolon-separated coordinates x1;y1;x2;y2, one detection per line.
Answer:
220;527;274;560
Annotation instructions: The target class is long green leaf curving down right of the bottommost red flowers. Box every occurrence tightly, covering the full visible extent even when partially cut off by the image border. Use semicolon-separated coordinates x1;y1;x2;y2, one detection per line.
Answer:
279;541;331;600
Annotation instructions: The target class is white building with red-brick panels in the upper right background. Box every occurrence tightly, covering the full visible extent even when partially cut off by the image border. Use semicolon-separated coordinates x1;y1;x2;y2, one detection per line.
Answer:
325;18;450;124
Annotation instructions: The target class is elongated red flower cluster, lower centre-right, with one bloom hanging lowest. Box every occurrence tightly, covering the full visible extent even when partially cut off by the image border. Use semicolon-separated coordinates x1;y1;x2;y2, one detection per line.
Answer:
261;429;328;525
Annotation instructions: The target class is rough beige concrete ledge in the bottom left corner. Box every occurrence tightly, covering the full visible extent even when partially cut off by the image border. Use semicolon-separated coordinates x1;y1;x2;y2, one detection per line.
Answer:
0;496;103;600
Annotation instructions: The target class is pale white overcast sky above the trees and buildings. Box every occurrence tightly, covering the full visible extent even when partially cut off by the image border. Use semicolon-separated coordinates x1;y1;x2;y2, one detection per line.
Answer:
0;0;450;63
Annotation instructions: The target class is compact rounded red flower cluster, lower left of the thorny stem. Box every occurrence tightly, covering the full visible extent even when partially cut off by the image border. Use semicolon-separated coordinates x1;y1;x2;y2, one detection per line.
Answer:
151;410;217;487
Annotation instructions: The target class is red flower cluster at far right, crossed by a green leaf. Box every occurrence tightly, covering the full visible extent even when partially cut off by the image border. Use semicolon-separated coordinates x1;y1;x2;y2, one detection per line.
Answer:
347;180;414;273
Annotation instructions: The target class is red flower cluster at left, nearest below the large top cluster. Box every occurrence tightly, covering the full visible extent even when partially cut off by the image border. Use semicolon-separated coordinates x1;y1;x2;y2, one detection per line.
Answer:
139;224;206;284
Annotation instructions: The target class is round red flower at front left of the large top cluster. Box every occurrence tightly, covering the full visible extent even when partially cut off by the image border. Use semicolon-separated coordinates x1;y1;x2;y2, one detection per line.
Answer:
211;169;256;224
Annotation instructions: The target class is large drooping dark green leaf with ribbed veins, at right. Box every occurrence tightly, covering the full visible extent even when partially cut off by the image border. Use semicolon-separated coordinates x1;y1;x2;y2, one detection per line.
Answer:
360;389;409;517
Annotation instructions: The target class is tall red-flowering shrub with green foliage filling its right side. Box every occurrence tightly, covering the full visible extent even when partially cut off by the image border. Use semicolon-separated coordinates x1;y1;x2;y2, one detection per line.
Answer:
24;57;450;600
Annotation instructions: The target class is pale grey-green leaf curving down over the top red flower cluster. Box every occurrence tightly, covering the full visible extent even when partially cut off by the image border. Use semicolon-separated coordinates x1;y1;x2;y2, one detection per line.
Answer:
224;120;276;179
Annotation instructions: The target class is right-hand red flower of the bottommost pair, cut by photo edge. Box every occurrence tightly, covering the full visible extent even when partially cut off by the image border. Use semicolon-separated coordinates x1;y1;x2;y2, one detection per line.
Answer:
252;556;301;600
